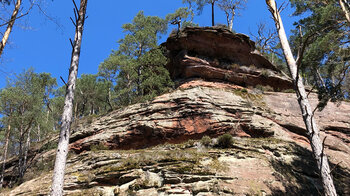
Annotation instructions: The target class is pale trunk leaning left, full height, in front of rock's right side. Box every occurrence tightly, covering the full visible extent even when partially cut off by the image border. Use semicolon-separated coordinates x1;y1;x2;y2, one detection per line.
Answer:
266;0;337;196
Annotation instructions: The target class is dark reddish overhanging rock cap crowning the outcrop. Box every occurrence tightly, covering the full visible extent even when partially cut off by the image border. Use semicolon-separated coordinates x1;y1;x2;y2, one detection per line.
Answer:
164;27;293;90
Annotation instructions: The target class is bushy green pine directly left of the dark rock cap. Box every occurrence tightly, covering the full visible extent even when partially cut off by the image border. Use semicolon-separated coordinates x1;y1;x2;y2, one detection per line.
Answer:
99;11;172;105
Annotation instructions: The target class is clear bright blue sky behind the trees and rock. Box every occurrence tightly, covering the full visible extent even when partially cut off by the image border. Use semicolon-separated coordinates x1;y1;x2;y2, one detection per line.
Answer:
0;0;294;88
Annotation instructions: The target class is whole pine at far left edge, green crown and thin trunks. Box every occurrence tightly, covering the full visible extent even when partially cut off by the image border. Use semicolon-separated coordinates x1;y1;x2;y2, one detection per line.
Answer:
0;69;56;187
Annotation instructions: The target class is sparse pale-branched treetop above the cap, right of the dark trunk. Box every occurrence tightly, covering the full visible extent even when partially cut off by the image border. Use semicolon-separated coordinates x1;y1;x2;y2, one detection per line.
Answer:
218;0;248;31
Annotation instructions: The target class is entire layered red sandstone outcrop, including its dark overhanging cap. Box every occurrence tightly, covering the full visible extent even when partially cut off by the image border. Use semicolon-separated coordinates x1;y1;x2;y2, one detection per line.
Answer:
0;28;350;196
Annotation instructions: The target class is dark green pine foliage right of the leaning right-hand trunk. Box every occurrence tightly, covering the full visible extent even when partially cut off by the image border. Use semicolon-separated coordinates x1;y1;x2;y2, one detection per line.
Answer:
291;0;350;109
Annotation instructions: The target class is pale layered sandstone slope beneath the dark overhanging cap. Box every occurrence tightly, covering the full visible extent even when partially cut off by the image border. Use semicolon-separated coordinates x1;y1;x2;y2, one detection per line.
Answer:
4;80;350;195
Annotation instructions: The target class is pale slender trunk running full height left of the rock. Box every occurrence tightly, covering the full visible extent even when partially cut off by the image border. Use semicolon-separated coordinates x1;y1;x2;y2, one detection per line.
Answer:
50;0;87;196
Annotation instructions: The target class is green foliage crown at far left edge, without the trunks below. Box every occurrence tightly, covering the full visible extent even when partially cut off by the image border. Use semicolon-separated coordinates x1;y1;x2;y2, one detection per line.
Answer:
0;69;56;140
